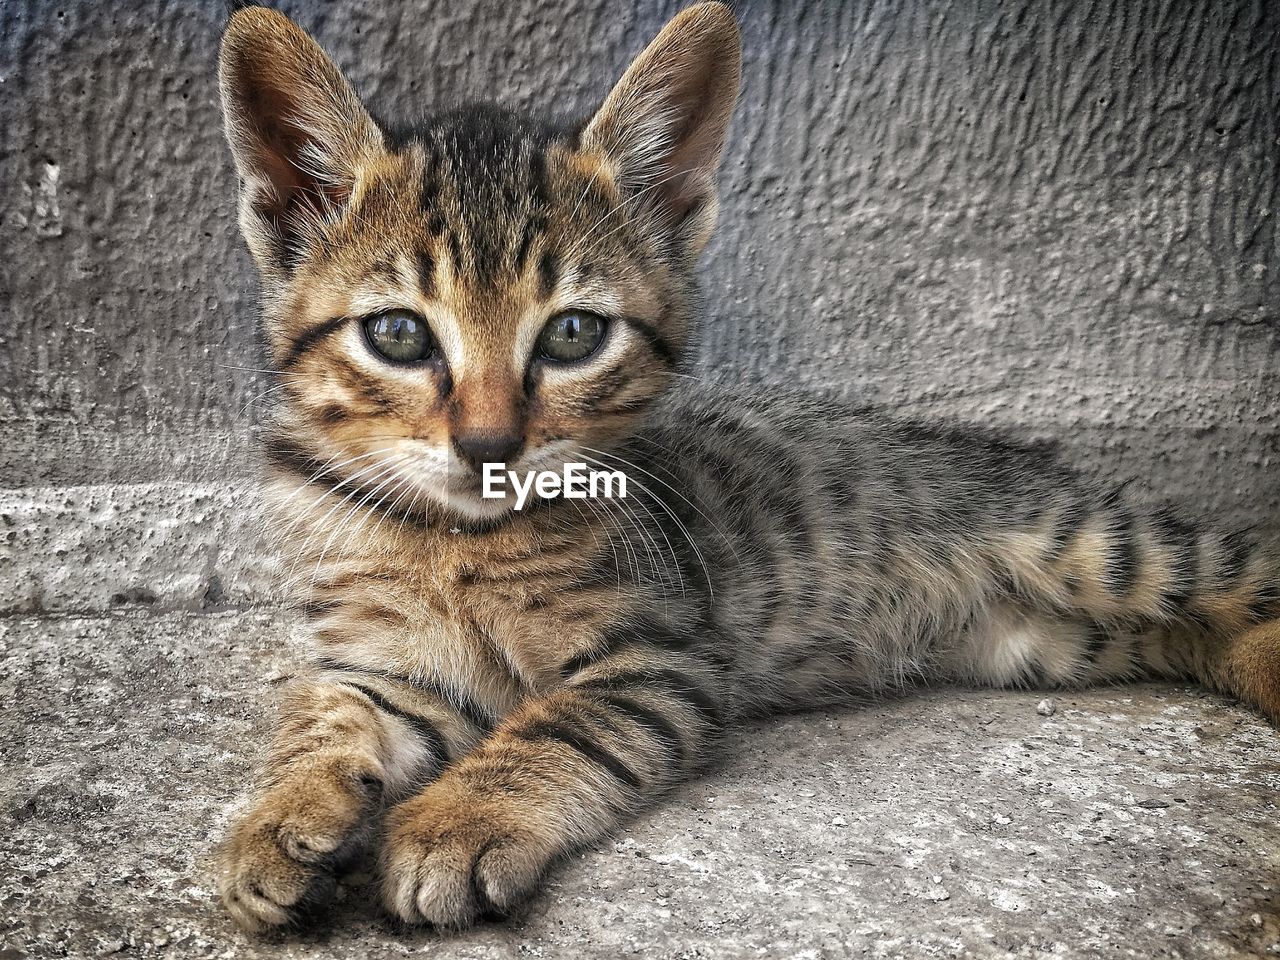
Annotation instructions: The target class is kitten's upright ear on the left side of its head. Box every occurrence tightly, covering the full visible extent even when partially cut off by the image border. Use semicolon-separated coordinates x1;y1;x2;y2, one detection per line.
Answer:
218;6;383;276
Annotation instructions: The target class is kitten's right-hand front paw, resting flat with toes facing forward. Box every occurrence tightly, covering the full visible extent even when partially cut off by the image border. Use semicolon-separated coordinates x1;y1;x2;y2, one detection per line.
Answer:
381;782;557;929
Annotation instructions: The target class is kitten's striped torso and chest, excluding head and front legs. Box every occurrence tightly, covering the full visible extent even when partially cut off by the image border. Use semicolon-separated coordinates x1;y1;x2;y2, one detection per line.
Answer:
274;388;1266;723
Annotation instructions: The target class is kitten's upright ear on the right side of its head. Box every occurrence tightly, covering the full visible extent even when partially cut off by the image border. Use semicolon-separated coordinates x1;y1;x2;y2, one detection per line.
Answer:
582;3;741;255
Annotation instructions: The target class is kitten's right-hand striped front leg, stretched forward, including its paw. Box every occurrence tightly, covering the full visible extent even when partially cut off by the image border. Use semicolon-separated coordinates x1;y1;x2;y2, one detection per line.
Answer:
381;660;724;927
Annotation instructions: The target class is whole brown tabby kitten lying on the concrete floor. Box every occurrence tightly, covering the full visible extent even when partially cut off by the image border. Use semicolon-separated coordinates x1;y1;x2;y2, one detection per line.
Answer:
220;3;1280;929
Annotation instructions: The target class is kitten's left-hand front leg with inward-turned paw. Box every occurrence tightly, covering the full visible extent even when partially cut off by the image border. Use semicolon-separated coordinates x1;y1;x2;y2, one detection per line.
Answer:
218;671;480;931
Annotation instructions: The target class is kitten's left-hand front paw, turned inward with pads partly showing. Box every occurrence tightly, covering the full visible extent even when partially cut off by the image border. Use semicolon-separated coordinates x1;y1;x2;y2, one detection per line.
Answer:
218;778;379;932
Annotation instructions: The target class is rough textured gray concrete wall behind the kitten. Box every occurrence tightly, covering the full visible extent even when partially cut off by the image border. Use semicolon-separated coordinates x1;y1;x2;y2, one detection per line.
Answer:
0;0;1280;611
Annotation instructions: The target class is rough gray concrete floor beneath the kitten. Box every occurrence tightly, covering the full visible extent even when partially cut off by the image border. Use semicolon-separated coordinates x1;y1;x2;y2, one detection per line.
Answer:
0;612;1280;960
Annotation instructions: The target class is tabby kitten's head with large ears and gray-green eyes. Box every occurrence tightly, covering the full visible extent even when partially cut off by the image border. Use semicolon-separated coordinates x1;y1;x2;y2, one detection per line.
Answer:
220;3;740;518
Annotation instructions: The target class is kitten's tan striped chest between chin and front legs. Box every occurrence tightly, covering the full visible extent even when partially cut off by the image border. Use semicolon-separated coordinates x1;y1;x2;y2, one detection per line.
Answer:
300;519;631;700
